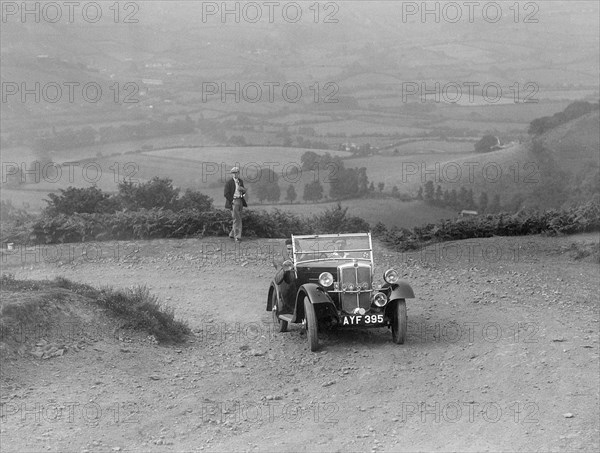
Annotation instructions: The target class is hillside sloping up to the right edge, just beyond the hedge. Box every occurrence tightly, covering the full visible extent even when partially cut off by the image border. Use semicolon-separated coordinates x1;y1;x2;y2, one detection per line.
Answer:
430;110;600;208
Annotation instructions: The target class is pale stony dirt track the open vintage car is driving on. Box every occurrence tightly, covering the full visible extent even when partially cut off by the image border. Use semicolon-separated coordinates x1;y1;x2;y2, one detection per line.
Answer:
1;235;600;452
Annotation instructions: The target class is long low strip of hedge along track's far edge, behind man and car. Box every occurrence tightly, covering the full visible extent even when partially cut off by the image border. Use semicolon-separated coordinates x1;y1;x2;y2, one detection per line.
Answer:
16;199;600;250
